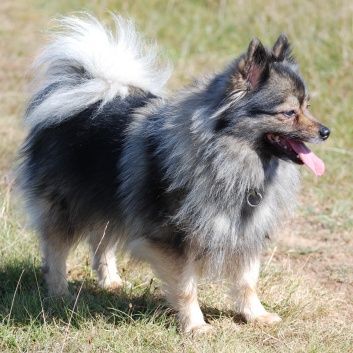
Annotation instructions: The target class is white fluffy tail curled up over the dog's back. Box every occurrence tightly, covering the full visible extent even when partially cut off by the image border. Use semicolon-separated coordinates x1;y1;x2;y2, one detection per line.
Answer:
25;13;171;127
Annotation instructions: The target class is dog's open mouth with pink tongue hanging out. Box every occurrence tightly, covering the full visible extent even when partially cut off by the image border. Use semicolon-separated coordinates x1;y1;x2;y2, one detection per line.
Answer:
266;134;325;176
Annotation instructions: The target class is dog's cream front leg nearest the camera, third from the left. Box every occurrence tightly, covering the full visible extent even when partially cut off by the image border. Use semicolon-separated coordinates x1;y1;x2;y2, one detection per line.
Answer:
129;239;212;334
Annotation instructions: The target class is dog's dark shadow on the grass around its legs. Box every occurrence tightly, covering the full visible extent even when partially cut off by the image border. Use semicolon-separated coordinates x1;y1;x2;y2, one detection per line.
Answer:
0;261;243;328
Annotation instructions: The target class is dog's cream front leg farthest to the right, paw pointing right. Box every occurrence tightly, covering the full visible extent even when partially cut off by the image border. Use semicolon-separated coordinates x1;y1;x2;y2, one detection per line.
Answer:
231;258;281;325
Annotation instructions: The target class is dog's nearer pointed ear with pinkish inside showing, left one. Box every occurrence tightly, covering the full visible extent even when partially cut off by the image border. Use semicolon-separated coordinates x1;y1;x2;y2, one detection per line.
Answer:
238;38;269;90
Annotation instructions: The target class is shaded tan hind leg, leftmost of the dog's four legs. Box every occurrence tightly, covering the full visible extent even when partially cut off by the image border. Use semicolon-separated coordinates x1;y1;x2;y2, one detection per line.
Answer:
41;234;71;296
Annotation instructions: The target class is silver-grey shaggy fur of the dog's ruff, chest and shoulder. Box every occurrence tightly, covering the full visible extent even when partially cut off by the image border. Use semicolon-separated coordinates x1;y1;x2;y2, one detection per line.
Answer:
121;81;299;276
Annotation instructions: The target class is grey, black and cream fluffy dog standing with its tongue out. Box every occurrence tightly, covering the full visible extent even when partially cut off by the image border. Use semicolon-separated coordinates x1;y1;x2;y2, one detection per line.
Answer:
18;14;330;333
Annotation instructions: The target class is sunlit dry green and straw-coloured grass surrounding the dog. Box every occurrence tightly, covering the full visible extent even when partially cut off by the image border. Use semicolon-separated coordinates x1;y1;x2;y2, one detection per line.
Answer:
0;0;353;353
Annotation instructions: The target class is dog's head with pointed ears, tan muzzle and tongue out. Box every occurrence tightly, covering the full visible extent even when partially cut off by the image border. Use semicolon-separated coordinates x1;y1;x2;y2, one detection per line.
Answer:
216;34;330;175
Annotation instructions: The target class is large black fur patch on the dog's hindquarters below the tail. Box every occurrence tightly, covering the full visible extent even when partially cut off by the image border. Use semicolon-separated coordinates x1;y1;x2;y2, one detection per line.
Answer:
22;93;152;237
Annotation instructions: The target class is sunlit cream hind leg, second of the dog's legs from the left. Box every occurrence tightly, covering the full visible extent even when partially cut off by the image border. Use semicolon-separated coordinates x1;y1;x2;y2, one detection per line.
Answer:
88;228;123;289
